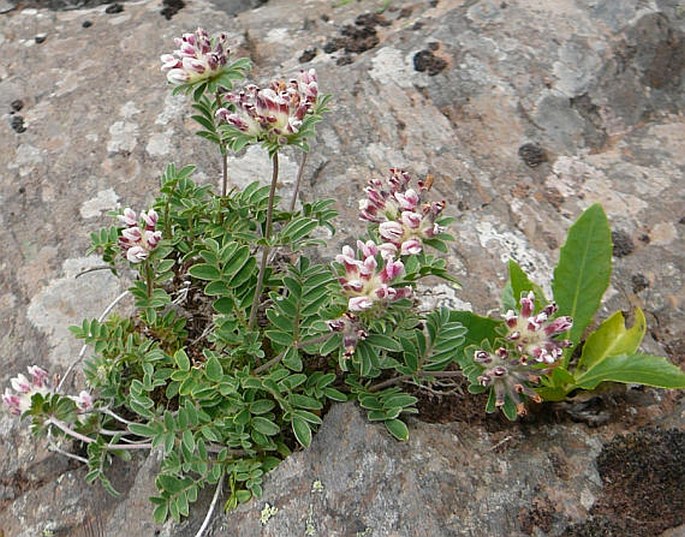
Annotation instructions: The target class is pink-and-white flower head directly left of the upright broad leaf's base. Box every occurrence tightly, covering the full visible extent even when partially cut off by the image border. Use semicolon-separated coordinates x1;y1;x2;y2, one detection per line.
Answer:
504;291;573;364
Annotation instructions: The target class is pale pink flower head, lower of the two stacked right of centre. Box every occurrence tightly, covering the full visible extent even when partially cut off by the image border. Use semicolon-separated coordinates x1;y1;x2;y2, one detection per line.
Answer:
335;241;412;312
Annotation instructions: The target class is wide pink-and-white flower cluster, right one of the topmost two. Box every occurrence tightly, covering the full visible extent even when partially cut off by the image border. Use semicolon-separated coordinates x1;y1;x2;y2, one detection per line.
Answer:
216;69;319;143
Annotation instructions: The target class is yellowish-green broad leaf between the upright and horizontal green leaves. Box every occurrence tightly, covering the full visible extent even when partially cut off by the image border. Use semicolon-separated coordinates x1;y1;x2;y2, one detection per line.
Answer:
578;308;647;371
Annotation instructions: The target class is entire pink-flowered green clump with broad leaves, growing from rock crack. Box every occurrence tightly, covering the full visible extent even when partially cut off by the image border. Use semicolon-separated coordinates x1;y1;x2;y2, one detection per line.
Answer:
3;29;685;535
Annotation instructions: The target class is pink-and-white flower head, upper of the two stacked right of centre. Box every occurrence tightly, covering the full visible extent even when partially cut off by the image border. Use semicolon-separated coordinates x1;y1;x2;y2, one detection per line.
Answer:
359;168;445;255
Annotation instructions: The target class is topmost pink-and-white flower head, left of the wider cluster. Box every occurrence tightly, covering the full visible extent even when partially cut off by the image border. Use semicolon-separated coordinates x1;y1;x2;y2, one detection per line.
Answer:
160;28;228;85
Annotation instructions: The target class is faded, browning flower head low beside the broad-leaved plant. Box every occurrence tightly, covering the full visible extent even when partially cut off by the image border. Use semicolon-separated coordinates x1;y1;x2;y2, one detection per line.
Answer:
473;347;550;416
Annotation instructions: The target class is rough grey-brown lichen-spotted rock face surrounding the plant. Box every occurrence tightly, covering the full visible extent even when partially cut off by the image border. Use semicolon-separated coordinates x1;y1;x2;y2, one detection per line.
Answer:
0;0;685;537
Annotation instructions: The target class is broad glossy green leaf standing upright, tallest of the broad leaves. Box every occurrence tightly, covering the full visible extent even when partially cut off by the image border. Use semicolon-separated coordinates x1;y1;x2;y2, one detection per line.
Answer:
552;204;612;344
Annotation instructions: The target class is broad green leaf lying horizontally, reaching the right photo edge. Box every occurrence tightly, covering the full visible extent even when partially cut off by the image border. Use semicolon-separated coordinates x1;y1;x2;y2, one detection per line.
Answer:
576;353;685;390
